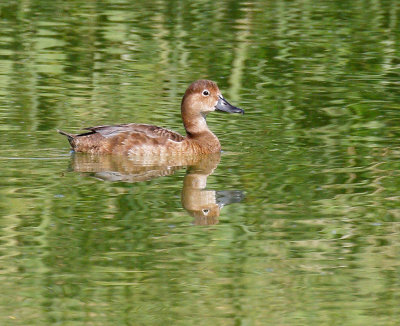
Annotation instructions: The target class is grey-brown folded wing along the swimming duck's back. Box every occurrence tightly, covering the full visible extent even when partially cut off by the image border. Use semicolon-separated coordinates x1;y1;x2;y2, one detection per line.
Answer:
83;123;184;142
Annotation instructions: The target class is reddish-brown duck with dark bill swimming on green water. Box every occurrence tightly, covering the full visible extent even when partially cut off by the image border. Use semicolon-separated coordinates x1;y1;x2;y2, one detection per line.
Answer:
57;79;244;157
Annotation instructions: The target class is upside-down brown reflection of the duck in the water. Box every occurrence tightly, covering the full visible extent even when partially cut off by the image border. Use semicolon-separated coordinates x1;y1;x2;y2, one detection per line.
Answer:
71;153;244;225
